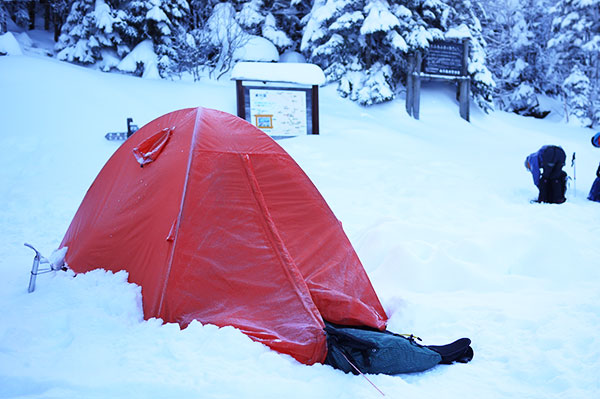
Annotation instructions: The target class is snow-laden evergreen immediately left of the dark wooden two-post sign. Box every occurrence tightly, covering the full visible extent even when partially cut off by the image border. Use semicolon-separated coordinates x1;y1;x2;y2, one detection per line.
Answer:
300;0;411;105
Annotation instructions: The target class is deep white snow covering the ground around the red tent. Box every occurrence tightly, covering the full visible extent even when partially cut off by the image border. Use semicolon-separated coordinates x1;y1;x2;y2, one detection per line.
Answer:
0;31;600;399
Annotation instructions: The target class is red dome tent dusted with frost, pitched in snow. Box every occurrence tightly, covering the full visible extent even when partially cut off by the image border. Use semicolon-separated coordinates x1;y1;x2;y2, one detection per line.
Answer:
61;108;387;364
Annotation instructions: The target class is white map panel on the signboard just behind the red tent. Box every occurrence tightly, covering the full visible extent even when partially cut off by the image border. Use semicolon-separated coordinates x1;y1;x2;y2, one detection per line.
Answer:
249;89;307;136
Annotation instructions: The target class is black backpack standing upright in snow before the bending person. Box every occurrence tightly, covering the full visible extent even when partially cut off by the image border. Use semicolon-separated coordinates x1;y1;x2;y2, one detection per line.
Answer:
538;146;567;204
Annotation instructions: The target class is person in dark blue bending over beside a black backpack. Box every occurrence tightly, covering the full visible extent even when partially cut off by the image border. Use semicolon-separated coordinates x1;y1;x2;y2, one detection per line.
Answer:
525;145;567;204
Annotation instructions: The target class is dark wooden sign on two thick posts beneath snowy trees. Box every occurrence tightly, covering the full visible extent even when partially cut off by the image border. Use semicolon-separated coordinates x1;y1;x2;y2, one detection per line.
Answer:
406;39;471;121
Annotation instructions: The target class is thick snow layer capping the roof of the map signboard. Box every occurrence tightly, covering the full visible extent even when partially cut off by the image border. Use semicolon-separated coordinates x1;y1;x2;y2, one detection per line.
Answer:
231;62;325;86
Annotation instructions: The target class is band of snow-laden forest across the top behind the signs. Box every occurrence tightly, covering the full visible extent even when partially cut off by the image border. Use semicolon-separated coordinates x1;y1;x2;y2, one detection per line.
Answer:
0;0;600;127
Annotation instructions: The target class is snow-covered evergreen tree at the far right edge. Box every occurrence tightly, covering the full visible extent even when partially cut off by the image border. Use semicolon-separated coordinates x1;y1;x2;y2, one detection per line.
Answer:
548;0;600;126
